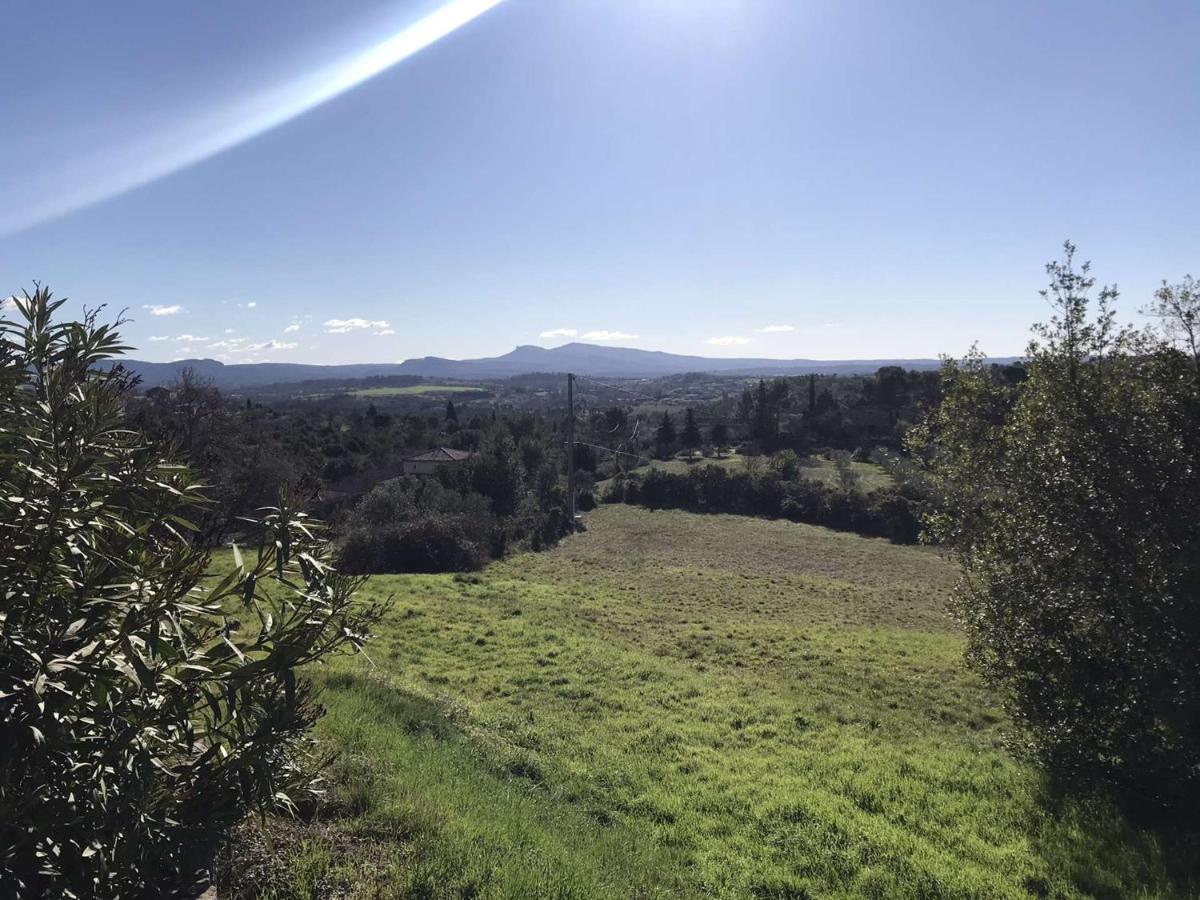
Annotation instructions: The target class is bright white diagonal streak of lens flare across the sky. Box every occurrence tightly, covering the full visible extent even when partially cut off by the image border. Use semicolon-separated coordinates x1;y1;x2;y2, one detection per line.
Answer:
0;0;503;236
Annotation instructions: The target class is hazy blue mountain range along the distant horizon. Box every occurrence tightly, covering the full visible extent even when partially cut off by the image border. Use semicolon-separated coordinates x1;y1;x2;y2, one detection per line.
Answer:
117;343;1012;389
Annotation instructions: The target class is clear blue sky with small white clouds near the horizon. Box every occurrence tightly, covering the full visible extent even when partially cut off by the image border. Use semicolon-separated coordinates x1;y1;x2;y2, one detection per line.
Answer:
0;0;1200;364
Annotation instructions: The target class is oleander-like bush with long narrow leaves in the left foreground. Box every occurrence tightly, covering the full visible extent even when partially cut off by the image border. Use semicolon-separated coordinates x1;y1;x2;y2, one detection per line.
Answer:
0;288;382;896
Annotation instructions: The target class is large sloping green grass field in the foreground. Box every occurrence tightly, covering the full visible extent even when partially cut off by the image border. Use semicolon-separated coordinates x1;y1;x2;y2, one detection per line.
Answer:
223;505;1200;900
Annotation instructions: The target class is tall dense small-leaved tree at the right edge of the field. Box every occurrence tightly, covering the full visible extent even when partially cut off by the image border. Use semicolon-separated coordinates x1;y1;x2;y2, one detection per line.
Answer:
910;244;1200;802
